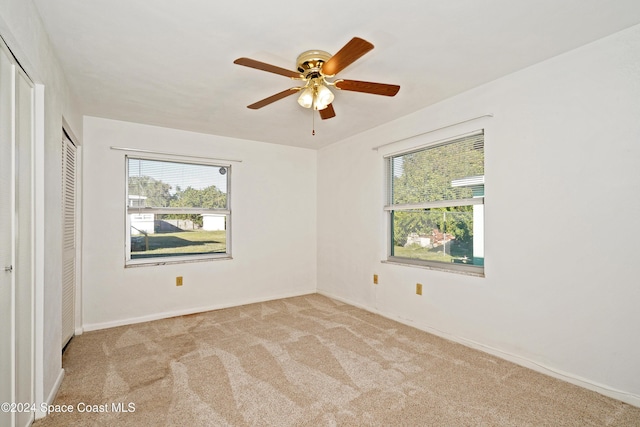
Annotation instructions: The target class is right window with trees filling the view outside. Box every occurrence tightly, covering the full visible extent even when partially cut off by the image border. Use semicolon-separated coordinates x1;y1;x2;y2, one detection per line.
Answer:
385;131;484;274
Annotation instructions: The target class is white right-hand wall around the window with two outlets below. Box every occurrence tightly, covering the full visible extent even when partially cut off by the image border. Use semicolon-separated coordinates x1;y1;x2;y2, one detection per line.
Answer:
318;26;640;406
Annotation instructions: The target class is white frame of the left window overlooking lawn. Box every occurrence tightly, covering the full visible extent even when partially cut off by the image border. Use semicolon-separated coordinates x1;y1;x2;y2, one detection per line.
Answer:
124;154;233;268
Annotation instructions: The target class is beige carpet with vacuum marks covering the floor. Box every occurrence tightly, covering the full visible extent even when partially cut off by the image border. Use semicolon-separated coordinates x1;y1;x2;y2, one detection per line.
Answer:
34;295;640;427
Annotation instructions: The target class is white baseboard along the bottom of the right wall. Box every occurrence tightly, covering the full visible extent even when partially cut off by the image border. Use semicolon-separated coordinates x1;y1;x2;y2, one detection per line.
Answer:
317;291;640;407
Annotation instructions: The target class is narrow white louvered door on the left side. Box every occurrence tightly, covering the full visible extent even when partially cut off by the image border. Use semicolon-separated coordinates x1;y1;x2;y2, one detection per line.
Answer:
62;136;76;348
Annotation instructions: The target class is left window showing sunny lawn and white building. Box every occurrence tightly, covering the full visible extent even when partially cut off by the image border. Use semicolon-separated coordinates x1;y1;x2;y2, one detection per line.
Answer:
126;156;231;265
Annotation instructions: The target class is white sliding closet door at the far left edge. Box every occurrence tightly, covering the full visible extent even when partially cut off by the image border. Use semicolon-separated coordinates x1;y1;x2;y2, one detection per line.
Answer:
0;39;34;427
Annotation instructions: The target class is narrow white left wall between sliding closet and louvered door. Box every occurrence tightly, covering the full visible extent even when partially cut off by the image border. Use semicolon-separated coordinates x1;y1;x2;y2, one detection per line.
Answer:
0;0;82;416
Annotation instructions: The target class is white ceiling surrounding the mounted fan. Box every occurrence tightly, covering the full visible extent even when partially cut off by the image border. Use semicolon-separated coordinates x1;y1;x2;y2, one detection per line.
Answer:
34;0;640;148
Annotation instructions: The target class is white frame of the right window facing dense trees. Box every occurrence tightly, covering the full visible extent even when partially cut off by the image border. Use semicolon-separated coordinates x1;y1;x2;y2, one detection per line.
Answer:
382;128;486;277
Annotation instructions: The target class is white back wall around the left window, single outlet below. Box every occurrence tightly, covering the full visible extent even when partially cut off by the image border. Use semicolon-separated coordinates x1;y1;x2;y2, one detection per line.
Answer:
83;117;317;329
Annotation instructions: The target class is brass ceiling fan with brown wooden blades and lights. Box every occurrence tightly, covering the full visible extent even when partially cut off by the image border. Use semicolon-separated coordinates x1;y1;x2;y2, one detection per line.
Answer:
233;37;400;120
